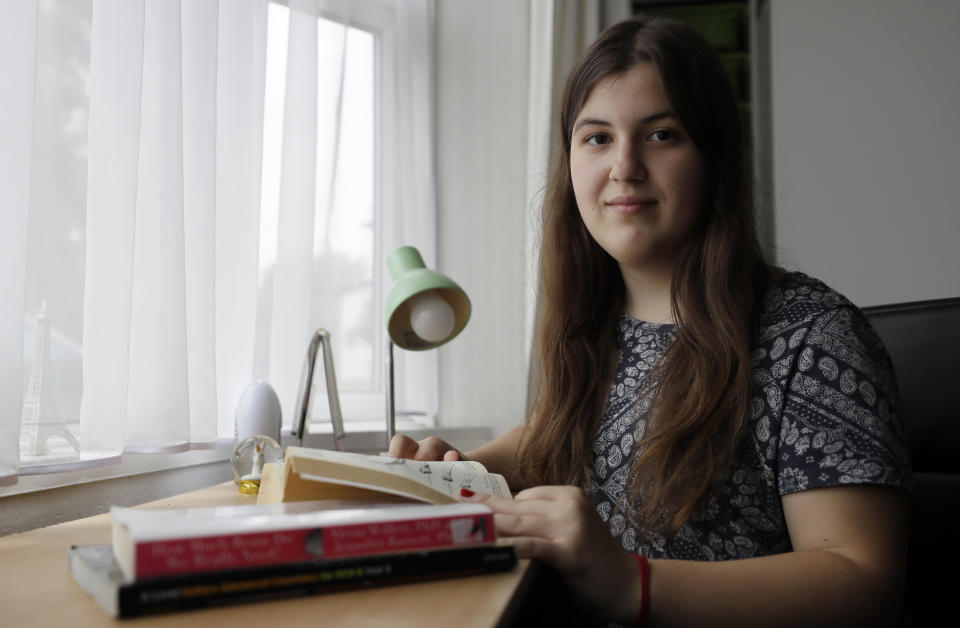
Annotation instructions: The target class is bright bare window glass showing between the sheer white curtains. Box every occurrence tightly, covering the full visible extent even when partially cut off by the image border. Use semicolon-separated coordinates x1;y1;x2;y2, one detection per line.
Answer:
257;2;383;419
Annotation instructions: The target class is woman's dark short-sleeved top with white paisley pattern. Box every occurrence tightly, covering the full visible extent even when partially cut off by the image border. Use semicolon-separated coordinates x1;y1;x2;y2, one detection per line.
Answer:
584;273;912;560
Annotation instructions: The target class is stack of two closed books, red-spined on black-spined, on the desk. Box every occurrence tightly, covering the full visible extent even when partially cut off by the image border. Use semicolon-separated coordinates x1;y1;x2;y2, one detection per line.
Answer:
69;448;517;617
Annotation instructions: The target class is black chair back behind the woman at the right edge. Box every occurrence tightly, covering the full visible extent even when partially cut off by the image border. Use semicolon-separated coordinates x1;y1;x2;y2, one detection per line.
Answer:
864;298;960;626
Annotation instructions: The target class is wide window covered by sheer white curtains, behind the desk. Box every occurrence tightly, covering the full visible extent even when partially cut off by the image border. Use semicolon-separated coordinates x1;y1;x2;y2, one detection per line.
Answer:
0;0;436;475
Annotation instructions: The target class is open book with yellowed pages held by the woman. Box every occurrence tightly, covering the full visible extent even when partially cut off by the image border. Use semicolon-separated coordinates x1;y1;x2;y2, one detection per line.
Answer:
257;447;510;504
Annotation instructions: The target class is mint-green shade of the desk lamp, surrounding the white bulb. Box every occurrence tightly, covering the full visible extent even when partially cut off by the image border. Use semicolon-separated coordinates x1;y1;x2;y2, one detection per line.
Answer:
385;246;470;351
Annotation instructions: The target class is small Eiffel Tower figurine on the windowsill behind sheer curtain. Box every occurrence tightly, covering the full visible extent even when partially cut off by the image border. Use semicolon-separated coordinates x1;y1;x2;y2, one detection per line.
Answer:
20;301;80;456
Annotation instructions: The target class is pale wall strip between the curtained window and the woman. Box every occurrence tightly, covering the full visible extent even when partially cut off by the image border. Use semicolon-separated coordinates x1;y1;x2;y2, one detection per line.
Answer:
436;0;529;434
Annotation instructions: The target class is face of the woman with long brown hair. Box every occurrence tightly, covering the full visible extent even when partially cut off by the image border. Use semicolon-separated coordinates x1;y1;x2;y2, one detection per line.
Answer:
570;63;707;272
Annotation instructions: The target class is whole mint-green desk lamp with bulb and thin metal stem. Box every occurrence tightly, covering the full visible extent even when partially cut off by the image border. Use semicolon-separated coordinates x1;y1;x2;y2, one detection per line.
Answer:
386;246;470;447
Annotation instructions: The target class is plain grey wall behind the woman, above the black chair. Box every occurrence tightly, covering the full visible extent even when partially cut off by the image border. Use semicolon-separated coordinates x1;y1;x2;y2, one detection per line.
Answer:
770;0;960;306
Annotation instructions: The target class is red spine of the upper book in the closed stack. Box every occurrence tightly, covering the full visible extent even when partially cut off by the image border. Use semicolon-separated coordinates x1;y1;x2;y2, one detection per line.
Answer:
135;513;495;579
